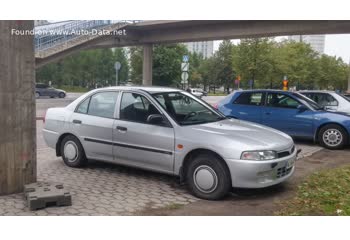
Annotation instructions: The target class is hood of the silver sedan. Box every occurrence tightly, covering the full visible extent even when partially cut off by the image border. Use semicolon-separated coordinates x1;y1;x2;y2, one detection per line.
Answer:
191;119;294;151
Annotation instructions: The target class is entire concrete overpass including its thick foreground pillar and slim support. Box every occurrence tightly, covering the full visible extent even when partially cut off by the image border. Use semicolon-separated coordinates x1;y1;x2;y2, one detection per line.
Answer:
0;20;350;195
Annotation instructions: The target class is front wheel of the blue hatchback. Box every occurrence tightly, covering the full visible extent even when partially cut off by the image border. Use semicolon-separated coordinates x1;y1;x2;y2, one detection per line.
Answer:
317;124;348;150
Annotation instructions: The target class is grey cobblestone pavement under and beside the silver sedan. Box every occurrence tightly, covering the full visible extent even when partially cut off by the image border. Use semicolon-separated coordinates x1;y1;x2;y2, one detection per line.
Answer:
0;124;321;216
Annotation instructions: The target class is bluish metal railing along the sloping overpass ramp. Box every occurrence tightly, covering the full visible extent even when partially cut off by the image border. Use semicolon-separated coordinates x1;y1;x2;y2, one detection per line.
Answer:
34;20;139;52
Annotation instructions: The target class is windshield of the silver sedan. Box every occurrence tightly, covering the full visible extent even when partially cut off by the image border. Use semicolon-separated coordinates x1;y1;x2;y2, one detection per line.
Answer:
152;92;225;125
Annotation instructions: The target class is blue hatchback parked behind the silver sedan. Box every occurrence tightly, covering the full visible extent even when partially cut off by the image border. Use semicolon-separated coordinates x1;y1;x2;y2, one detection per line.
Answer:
217;90;350;149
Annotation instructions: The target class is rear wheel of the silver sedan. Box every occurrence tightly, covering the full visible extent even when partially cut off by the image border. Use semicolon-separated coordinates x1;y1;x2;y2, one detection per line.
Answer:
60;135;87;168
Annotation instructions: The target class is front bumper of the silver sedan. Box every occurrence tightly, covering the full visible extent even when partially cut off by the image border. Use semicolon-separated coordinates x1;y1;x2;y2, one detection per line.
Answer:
226;149;297;188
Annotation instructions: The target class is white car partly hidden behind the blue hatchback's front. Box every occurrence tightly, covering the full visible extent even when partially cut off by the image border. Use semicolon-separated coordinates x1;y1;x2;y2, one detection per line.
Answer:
300;90;350;113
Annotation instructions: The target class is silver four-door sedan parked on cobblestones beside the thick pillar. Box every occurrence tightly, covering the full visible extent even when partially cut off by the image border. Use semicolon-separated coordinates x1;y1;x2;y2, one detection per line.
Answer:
43;87;297;200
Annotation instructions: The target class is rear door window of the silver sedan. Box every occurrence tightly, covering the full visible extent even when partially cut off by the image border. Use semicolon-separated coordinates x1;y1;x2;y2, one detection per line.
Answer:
86;92;118;118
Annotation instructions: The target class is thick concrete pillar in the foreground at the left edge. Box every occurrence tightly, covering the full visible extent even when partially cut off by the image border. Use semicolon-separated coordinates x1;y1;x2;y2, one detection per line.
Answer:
0;21;36;195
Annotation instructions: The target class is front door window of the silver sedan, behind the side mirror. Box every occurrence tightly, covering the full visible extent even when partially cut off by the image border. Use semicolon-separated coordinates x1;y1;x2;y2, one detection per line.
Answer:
120;92;161;123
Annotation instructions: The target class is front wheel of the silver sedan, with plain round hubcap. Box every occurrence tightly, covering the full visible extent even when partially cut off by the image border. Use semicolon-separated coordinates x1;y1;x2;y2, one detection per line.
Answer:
185;153;232;200
